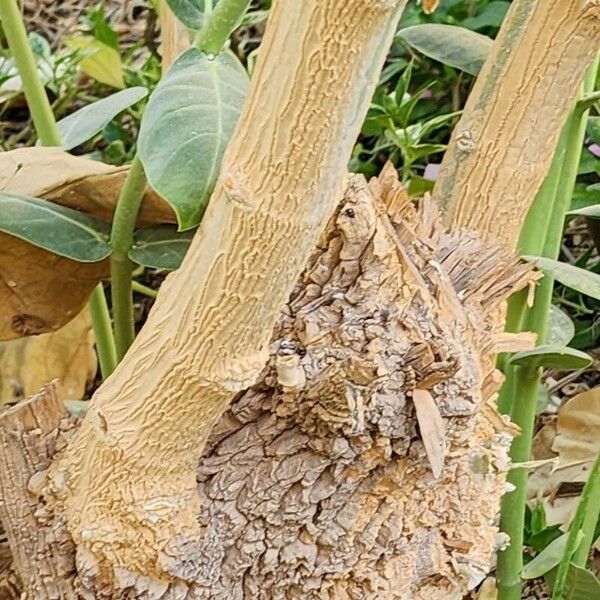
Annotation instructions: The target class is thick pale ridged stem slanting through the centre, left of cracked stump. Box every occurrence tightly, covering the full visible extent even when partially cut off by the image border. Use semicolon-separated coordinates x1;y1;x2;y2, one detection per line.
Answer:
55;0;404;578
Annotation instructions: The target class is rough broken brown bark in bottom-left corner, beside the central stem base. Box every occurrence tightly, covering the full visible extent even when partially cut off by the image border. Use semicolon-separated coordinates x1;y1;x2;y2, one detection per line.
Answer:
0;385;75;600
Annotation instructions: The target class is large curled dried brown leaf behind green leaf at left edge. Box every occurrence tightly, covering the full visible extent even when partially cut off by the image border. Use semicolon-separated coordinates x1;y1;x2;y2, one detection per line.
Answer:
0;148;175;340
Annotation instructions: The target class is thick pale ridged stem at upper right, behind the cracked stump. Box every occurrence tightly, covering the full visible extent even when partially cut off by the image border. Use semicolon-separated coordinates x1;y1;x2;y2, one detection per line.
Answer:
434;0;600;249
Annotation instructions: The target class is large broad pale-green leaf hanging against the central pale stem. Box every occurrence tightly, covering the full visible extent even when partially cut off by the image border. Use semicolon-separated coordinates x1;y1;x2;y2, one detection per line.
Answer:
139;48;248;230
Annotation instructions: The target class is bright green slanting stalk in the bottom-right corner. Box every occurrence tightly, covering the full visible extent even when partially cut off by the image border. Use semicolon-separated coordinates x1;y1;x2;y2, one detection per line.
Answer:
552;452;600;600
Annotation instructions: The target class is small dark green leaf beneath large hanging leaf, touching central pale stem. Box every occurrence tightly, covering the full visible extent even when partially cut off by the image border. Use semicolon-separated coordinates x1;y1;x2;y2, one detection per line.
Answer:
129;225;196;271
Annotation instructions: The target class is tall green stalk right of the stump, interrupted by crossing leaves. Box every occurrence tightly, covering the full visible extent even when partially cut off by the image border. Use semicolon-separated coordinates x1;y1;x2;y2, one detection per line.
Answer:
497;58;598;600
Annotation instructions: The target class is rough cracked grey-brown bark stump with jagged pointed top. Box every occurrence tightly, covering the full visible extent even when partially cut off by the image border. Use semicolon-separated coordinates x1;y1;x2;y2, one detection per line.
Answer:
3;168;531;600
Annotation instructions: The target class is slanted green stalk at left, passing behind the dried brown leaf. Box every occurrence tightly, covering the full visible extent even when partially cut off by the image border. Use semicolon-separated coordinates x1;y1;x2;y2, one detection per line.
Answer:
0;0;116;378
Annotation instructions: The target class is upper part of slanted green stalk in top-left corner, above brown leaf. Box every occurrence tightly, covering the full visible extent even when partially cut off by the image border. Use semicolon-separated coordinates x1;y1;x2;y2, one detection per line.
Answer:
0;0;61;146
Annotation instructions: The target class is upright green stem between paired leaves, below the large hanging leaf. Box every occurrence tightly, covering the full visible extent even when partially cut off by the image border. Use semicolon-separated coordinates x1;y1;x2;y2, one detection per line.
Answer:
110;156;146;361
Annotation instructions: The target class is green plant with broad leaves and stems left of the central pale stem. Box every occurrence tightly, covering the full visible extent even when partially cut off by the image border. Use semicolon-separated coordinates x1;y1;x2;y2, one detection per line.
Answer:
0;0;250;368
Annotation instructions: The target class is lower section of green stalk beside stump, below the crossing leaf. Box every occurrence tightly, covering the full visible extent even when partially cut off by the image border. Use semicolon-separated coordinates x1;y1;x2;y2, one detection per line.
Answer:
497;367;541;600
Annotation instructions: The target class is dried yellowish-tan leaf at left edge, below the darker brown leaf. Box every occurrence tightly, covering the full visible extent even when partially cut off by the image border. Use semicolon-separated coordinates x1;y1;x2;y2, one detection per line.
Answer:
0;310;97;405
